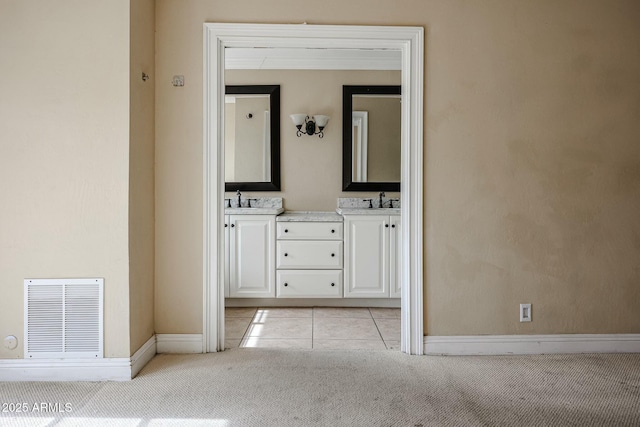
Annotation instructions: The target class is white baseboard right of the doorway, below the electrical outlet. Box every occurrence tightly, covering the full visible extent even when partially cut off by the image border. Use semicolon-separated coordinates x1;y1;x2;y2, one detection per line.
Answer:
424;334;640;355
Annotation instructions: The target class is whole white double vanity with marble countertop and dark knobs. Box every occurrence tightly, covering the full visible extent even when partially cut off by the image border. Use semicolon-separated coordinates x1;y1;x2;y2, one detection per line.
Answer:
225;198;400;299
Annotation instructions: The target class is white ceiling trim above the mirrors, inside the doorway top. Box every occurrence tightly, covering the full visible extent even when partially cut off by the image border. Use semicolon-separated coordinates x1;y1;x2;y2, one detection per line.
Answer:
225;48;402;71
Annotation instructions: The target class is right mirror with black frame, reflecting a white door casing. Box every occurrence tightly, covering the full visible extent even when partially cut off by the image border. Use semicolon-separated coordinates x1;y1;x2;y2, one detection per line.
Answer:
342;86;402;191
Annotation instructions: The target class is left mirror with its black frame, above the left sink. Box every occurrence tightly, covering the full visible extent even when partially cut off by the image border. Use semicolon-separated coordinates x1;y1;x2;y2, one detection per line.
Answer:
224;85;280;191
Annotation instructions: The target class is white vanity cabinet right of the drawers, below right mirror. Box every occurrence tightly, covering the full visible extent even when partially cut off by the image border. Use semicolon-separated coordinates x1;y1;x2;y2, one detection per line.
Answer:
344;214;400;298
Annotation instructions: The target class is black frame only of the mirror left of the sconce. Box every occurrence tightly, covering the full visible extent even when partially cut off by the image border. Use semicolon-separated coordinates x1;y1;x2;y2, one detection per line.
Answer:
224;85;280;191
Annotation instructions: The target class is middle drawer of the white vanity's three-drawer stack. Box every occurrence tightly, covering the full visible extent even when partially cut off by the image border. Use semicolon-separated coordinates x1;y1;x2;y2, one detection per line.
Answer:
276;240;342;269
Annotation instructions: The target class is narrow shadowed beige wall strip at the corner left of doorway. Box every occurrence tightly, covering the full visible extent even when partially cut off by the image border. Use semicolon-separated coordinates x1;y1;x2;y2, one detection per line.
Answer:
129;0;156;354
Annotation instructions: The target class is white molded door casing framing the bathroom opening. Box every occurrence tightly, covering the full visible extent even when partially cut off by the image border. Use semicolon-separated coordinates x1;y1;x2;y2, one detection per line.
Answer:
202;23;424;354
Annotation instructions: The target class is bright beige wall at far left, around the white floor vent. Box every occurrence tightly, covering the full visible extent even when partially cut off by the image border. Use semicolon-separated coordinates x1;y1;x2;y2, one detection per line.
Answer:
0;0;130;358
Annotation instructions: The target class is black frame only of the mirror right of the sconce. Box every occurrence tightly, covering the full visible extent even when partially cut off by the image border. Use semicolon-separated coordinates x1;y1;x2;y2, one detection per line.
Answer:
342;85;401;191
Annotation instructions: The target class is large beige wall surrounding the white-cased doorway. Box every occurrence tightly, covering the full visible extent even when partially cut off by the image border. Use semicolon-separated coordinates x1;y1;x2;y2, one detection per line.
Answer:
156;0;640;335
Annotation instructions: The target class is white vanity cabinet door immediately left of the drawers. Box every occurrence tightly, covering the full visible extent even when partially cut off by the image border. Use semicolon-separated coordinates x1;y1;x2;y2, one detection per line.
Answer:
229;215;276;298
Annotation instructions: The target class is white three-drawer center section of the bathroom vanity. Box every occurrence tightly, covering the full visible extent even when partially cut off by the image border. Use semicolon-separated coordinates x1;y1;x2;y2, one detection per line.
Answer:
276;214;343;298
